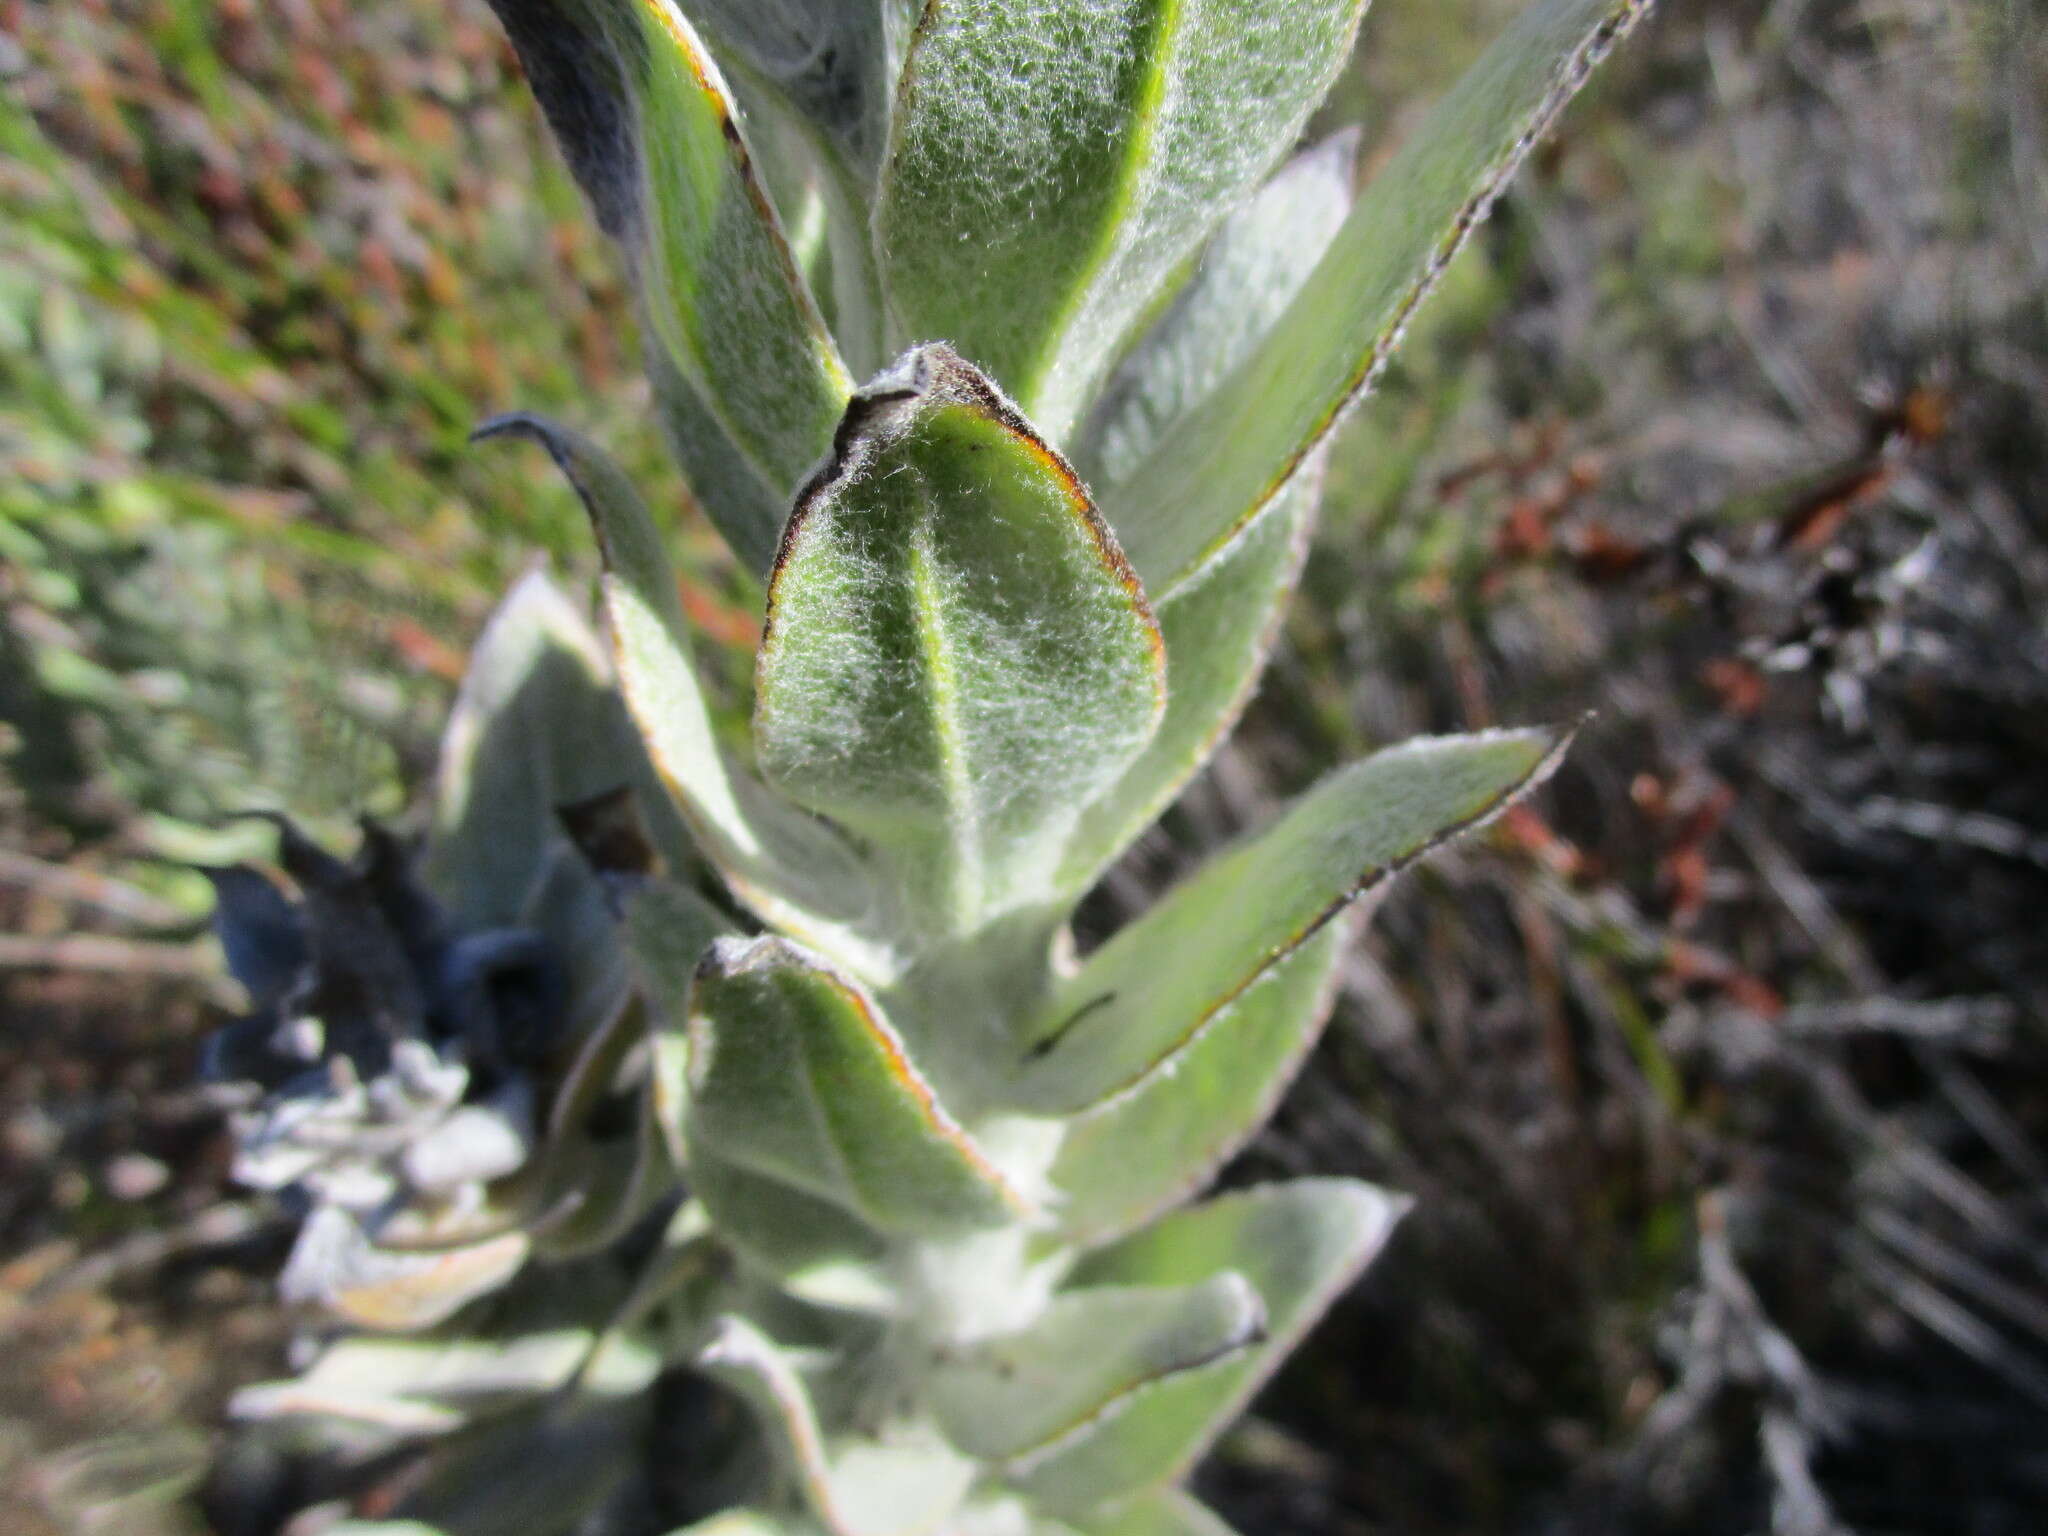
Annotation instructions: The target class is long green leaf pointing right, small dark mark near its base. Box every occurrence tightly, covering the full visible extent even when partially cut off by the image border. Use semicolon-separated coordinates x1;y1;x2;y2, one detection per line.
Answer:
1012;731;1567;1114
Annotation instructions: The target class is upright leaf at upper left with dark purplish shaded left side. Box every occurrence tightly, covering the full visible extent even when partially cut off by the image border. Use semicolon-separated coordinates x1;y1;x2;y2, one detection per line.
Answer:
494;0;850;569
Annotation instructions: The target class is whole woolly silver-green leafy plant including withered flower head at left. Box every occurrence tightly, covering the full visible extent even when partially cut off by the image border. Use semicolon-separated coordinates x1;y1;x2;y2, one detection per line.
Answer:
211;0;1642;1536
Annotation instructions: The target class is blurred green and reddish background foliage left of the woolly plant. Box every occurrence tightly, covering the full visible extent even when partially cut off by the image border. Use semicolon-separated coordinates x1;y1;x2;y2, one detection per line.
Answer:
0;0;748;884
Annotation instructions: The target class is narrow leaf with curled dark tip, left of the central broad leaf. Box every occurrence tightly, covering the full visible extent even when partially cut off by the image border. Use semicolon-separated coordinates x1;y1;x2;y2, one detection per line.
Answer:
477;414;891;973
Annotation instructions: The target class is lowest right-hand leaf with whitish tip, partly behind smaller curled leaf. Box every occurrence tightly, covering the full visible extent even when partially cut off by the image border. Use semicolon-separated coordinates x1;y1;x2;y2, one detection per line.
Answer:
1012;1180;1405;1532
